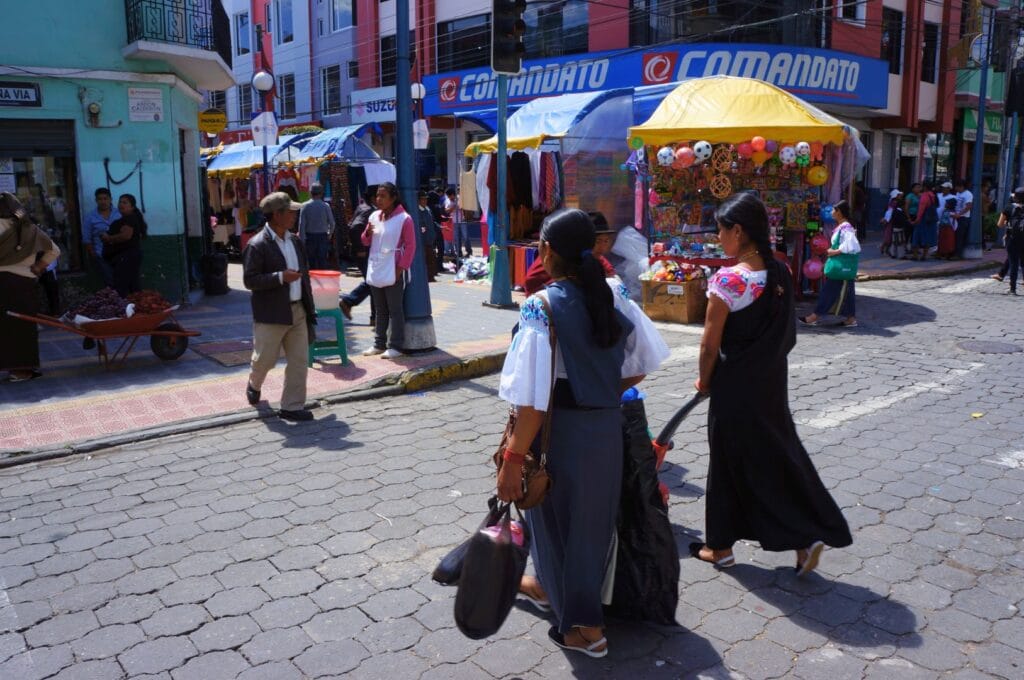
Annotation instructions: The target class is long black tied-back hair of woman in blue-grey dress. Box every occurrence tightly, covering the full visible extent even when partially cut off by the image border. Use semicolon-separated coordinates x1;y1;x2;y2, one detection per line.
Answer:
541;208;623;347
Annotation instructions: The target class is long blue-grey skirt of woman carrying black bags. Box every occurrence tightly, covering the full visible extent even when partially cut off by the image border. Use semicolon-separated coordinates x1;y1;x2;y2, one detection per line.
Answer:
525;407;623;634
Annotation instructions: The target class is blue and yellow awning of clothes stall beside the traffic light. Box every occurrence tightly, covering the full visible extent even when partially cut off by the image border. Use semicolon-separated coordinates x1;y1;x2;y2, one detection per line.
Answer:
466;88;631;156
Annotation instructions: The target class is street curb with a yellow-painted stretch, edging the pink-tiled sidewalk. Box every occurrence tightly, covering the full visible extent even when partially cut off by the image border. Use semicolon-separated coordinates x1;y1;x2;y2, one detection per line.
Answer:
0;350;505;470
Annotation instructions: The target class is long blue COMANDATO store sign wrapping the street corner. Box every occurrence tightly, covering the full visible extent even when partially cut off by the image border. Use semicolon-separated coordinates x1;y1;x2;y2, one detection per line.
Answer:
424;43;889;115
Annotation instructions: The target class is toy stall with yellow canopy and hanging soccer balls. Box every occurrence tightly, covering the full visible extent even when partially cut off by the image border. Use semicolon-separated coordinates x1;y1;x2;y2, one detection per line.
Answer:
627;76;867;317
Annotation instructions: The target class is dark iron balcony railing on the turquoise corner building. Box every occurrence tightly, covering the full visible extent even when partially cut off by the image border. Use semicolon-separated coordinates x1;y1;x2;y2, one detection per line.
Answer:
125;0;230;63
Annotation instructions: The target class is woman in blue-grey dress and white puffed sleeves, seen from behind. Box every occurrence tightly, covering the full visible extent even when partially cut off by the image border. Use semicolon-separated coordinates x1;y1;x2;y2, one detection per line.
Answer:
497;209;668;657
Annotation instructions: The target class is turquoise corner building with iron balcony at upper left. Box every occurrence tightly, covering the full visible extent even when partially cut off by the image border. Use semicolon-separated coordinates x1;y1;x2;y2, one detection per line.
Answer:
0;0;232;300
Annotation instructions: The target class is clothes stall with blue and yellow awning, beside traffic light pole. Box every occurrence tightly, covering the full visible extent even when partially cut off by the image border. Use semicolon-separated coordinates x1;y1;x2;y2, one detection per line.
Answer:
463;89;633;286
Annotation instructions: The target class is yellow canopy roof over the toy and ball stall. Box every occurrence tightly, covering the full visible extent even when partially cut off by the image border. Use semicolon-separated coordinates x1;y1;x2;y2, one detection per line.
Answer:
627;76;846;148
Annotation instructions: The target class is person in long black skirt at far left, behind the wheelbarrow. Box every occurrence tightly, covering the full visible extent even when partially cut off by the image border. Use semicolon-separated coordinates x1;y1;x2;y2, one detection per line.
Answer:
0;193;60;382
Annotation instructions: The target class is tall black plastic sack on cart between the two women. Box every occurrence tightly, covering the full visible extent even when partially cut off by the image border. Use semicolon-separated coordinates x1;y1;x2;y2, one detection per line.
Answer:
608;399;679;625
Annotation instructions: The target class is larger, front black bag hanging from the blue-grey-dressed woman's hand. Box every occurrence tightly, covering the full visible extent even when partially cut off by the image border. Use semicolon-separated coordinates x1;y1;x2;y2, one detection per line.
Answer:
455;504;529;640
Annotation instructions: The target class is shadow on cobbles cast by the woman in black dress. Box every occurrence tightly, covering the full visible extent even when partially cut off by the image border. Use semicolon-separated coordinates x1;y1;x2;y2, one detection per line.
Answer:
723;564;922;647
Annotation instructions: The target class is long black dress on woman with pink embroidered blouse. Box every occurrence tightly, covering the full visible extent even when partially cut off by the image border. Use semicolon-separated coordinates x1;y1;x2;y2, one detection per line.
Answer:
706;261;853;551
